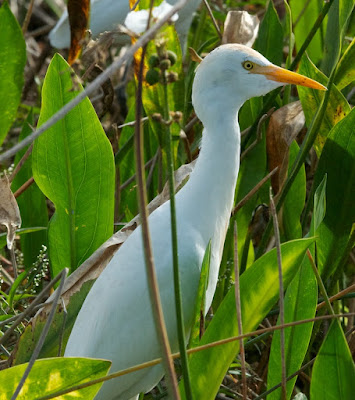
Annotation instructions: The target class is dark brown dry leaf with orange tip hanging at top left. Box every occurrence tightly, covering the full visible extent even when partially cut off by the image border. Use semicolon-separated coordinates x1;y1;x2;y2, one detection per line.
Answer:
68;0;90;65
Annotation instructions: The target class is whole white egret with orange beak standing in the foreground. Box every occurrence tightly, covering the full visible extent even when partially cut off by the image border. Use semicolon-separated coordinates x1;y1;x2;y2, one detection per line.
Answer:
65;44;324;400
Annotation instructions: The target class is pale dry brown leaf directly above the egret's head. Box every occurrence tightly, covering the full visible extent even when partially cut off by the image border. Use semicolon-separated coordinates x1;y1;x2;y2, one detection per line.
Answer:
222;11;259;47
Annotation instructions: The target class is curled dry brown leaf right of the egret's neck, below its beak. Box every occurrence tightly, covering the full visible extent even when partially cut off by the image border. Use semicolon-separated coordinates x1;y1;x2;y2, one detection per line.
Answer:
266;101;305;195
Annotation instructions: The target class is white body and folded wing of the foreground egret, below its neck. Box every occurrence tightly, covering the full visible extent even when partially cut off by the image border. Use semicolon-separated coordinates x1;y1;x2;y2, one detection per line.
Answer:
65;207;203;398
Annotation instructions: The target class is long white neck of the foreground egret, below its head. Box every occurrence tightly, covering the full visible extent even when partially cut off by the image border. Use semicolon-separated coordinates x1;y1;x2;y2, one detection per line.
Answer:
181;111;240;246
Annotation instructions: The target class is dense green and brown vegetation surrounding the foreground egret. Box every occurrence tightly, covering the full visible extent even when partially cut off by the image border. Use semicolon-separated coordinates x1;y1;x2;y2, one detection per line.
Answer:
0;0;355;400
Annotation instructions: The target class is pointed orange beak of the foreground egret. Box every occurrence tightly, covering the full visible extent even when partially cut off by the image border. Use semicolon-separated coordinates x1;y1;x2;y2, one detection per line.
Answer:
250;65;327;90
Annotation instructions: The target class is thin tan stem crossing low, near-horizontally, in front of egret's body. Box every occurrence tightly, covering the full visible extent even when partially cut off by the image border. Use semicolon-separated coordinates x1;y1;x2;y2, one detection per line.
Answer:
37;312;355;400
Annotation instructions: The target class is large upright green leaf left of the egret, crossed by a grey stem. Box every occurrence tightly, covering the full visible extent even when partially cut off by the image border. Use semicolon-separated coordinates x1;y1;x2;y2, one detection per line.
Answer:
32;54;115;276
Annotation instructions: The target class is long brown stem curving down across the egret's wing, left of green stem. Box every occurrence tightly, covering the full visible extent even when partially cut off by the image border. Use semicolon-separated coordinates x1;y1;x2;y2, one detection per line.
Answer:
135;22;180;400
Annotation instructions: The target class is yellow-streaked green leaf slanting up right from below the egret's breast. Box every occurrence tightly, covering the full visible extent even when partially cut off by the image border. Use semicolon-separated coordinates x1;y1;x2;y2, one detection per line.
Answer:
180;238;314;400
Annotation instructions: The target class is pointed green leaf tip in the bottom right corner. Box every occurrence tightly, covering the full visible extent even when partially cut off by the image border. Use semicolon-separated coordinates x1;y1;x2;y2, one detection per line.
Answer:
311;320;355;400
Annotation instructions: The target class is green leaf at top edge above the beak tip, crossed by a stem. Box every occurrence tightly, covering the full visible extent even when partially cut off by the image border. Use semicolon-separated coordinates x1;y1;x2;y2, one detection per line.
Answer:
289;0;323;63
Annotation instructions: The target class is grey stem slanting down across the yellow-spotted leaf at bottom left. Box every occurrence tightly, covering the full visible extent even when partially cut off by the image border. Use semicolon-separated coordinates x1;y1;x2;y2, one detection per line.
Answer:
11;268;69;400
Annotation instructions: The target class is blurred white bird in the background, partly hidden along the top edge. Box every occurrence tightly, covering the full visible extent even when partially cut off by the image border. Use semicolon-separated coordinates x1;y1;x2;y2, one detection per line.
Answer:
49;0;201;49
